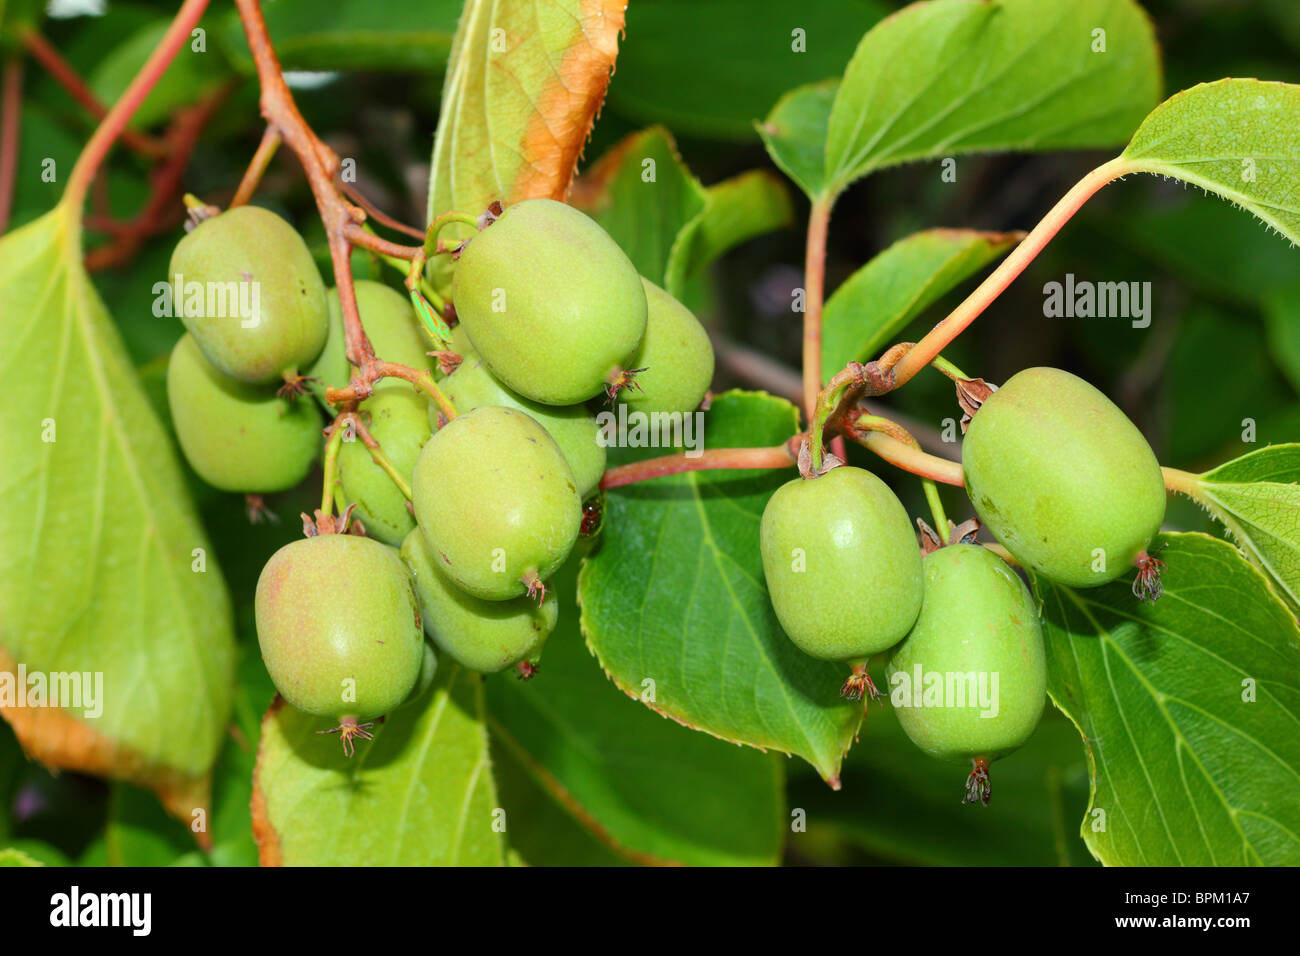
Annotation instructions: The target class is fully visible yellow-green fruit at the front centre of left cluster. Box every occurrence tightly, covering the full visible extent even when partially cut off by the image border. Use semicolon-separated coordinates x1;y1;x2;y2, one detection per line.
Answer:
412;406;582;601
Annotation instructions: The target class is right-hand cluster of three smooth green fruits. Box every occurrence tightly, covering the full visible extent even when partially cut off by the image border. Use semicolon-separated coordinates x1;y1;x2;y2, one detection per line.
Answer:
761;368;1165;804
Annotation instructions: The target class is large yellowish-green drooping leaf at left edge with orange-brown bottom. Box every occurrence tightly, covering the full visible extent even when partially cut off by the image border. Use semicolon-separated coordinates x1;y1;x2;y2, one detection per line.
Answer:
0;204;234;819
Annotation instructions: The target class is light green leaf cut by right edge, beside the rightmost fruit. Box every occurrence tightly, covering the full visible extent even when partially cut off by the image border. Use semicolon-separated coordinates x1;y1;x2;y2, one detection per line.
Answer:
1196;445;1300;607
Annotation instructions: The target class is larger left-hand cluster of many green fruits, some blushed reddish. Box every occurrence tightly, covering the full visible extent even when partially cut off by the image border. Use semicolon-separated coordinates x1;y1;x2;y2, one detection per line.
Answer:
168;200;714;752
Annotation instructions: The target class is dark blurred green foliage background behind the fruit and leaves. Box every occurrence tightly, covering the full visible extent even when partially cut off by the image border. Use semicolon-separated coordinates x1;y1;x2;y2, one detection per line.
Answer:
0;0;1300;865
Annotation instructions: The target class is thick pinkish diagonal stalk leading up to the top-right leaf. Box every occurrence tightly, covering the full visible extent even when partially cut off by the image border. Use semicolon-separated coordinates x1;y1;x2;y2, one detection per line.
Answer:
889;157;1132;388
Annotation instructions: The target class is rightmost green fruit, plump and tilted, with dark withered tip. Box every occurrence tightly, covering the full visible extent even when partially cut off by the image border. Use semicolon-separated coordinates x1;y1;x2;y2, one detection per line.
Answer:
962;368;1165;588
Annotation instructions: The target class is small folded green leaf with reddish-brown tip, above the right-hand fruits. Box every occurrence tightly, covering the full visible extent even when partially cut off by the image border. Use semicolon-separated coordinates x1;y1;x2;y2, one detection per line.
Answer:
822;229;1021;380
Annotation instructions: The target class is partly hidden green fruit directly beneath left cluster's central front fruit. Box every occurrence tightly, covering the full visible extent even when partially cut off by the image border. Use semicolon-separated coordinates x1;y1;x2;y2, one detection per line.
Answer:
402;528;559;674
